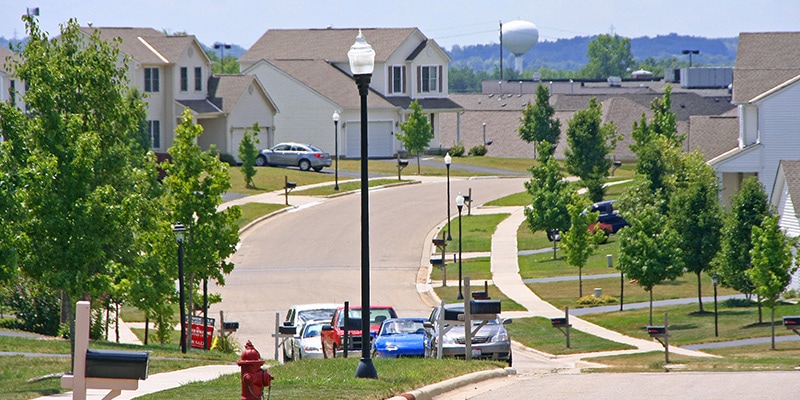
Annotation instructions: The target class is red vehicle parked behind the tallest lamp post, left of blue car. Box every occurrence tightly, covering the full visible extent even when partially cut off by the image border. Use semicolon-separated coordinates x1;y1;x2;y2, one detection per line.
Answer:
322;305;397;358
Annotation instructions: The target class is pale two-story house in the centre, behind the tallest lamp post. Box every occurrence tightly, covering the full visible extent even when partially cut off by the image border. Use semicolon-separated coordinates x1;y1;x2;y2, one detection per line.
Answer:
239;28;461;158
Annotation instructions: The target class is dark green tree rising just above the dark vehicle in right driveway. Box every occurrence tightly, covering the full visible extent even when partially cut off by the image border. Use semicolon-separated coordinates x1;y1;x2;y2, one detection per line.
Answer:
564;97;619;202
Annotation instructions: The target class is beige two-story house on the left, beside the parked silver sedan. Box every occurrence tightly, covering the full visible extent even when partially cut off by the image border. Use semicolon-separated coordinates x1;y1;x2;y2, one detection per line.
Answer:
81;27;278;156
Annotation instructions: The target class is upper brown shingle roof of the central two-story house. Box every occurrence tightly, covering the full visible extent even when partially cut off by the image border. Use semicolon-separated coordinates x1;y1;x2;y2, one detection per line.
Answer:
240;28;417;63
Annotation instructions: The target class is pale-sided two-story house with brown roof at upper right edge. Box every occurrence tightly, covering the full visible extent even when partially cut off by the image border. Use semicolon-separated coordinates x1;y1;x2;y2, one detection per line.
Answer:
709;32;800;204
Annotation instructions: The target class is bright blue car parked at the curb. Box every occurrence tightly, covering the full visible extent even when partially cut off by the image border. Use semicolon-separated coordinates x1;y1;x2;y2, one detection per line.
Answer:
372;318;428;358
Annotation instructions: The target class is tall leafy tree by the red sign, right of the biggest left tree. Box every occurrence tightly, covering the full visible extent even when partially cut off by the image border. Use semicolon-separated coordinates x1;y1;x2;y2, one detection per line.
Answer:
162;108;241;344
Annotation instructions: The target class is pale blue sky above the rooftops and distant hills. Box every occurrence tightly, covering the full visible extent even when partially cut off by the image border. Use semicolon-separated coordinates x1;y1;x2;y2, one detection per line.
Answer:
0;0;800;49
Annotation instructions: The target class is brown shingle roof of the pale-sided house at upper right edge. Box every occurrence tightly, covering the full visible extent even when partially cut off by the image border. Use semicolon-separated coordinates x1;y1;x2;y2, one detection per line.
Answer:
733;32;800;104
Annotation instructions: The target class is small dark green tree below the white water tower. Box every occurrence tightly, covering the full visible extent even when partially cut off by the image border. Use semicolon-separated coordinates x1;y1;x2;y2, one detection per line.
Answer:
517;84;561;155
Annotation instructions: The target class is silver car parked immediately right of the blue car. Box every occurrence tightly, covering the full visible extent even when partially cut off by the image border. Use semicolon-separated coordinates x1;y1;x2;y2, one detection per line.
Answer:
425;303;512;365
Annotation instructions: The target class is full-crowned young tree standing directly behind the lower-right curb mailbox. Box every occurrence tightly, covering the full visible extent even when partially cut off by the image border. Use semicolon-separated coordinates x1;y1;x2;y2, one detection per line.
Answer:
618;181;683;325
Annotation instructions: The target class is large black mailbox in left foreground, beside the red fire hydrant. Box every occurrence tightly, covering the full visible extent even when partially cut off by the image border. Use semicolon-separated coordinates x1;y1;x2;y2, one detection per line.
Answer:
86;350;150;379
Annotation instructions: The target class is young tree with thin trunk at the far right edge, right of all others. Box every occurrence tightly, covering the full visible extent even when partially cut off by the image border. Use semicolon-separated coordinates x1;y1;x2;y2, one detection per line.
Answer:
745;215;797;350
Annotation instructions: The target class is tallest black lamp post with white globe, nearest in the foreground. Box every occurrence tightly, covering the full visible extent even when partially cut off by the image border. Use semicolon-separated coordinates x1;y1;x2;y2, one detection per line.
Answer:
347;29;378;379
